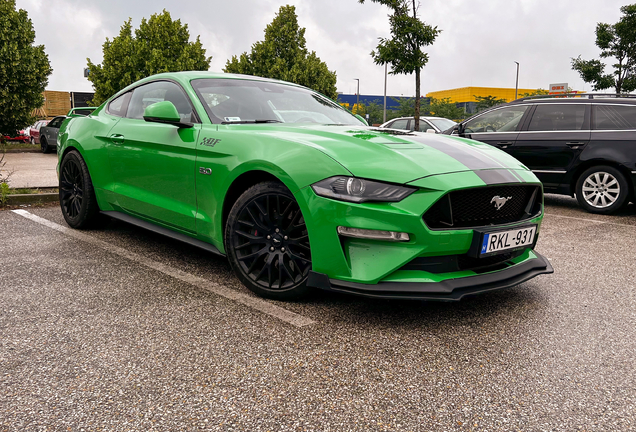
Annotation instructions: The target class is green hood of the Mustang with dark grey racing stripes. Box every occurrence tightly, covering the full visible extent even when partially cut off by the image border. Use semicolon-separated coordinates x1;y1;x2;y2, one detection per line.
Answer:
272;125;528;184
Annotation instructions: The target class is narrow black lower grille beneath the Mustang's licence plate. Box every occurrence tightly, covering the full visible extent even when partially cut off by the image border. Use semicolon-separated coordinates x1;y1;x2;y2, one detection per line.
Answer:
400;250;524;274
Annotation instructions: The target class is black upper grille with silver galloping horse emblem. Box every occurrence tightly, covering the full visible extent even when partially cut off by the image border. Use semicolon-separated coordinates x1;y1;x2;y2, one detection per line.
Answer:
424;185;543;229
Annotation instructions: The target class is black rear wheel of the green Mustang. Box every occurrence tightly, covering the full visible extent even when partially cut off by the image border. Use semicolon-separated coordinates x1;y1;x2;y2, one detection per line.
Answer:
59;150;99;229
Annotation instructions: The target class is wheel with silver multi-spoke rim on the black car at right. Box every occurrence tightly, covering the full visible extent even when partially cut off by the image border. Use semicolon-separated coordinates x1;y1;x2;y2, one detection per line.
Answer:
576;165;629;214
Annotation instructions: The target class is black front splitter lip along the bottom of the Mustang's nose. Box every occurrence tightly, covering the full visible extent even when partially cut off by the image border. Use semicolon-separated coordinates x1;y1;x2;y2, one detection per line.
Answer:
307;251;554;301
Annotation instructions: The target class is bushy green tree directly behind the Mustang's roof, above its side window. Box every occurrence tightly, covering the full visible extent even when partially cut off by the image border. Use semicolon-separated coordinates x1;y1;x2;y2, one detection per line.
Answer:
86;9;212;106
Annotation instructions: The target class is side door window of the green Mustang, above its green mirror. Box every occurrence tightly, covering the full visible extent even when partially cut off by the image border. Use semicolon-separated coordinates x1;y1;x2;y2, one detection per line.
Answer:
126;81;195;122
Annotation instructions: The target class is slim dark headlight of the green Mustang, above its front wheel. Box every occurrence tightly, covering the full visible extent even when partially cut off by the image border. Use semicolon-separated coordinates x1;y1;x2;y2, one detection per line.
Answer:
311;176;416;203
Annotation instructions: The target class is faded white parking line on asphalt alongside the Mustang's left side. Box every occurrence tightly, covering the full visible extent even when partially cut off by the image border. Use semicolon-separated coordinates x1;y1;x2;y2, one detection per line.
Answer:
13;210;315;327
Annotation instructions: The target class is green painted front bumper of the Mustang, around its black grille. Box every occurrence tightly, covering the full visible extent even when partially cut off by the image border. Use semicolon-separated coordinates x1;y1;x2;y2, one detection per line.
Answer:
296;171;542;285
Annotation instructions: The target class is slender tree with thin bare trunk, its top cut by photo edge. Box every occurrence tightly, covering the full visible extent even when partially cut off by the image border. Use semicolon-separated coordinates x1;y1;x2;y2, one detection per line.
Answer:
358;0;441;129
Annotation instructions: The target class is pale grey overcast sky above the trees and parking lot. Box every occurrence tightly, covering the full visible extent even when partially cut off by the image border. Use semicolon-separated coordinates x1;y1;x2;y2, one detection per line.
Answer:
17;0;627;96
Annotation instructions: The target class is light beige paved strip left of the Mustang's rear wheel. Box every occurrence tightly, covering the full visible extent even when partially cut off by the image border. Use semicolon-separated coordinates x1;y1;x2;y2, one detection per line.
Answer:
0;153;58;188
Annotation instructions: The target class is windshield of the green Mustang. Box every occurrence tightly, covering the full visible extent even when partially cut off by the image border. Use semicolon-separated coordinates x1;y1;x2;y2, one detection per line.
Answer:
192;79;363;126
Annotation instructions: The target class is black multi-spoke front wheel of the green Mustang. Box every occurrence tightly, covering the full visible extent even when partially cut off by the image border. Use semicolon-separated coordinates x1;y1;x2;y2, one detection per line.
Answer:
225;181;311;300
